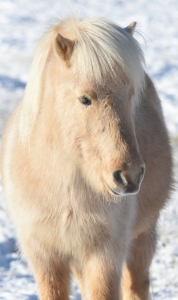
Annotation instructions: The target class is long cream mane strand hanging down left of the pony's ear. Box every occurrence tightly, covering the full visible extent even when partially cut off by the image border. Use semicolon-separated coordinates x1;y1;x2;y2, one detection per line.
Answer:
19;30;55;143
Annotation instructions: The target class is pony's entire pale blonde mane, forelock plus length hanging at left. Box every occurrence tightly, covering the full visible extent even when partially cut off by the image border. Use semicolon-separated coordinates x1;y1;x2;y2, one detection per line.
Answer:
20;16;144;141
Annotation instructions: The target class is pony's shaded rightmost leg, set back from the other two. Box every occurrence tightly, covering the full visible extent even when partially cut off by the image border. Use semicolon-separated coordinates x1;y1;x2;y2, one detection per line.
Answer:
122;228;156;300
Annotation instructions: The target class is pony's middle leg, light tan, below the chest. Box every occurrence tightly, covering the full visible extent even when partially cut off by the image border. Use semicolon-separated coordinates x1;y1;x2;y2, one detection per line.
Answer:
80;253;121;300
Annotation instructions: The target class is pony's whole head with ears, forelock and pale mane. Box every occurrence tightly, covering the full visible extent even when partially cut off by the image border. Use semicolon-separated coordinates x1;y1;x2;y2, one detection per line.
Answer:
20;17;144;195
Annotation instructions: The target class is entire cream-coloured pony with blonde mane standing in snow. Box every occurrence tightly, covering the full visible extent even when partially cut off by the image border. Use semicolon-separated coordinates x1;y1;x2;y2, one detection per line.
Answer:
1;17;172;300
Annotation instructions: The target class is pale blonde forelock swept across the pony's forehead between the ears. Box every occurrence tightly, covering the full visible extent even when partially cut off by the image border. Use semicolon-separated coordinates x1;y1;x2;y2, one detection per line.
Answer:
69;18;144;90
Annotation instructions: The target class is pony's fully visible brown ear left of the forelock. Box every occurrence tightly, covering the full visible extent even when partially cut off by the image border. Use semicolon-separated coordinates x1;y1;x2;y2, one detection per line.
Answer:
54;33;74;63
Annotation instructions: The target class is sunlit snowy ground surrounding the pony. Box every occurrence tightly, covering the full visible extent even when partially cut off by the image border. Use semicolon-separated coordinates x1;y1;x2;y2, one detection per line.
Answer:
0;0;178;300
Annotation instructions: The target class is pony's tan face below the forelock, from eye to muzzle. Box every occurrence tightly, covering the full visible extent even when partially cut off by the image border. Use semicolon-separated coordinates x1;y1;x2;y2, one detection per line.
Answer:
54;74;144;196
